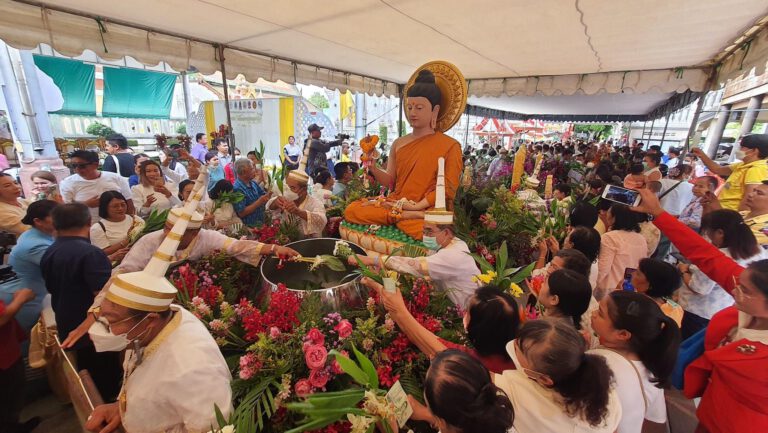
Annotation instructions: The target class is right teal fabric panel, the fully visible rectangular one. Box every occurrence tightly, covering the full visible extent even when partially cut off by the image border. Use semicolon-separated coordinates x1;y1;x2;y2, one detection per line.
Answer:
102;66;176;119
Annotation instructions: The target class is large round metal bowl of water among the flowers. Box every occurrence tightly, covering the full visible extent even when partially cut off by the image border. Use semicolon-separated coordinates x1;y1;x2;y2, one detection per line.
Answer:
261;238;367;311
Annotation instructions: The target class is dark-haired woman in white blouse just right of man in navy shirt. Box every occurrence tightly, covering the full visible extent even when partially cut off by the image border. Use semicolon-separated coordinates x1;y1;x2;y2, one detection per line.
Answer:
91;191;144;262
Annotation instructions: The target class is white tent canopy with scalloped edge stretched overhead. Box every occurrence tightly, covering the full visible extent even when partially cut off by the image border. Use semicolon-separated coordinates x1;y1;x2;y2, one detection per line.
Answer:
0;0;768;113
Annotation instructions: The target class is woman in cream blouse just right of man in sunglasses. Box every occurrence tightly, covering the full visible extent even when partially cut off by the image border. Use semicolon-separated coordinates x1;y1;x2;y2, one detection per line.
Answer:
131;160;181;218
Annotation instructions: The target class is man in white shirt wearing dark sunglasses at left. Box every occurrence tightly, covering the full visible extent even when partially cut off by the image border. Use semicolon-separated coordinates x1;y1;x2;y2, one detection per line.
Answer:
59;150;136;221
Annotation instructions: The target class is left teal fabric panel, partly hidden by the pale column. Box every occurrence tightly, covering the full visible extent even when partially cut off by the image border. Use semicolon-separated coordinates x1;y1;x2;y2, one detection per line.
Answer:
34;55;96;116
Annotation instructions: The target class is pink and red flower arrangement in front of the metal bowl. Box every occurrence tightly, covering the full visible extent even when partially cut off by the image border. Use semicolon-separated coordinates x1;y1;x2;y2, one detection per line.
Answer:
170;250;465;433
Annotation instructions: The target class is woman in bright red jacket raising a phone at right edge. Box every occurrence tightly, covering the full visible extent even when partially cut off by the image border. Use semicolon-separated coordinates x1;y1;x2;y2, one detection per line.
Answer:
633;189;768;433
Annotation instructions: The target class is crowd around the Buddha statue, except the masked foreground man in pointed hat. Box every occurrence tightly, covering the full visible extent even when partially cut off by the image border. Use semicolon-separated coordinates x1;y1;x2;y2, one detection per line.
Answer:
0;125;768;433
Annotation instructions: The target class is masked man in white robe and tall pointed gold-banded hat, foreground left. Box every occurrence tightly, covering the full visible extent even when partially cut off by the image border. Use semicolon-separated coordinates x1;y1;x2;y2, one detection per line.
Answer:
85;179;232;433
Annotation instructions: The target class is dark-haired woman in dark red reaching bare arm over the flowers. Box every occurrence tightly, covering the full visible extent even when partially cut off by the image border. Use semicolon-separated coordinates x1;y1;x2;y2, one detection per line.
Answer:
362;278;520;374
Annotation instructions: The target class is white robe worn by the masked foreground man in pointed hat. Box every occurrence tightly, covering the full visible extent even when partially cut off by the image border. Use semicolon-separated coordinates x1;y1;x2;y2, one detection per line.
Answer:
118;305;232;433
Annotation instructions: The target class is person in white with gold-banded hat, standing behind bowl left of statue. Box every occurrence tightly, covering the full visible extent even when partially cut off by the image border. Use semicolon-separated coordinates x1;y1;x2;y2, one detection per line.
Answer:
267;170;328;238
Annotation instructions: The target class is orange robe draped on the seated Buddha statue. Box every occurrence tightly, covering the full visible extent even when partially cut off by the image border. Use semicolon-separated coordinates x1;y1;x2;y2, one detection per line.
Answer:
344;132;464;239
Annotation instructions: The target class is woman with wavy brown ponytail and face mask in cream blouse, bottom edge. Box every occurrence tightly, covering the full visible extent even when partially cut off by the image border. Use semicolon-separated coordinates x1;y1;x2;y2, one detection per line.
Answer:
493;319;621;433
